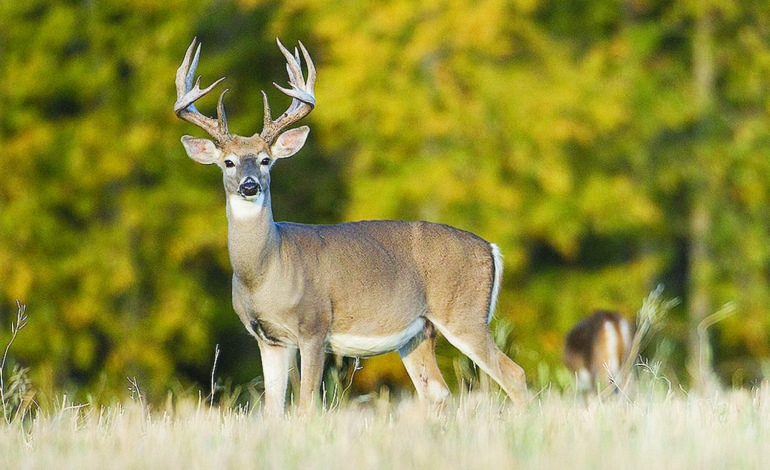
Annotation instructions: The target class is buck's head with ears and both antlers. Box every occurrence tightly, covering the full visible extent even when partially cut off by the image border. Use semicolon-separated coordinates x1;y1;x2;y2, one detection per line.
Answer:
174;39;315;202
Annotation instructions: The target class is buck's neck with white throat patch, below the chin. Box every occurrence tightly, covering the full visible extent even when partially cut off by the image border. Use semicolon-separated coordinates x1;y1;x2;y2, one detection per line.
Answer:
227;192;281;284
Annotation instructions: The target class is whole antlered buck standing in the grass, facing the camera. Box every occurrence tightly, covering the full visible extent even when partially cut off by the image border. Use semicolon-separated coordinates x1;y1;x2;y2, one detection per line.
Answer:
174;39;526;414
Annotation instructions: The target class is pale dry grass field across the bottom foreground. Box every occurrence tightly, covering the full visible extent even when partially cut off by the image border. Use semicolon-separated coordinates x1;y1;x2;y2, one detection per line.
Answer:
0;383;770;469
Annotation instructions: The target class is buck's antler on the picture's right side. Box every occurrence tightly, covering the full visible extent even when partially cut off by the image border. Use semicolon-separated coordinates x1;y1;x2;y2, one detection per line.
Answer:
259;39;315;145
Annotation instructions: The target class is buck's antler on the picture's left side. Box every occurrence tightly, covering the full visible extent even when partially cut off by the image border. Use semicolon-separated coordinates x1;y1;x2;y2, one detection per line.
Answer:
174;38;231;146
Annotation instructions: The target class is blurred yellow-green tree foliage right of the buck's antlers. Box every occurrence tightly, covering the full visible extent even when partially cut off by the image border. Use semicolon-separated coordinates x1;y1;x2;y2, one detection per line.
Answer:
266;0;770;388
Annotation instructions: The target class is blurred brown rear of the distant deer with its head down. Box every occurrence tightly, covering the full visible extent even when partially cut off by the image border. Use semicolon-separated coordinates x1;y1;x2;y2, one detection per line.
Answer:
564;310;633;392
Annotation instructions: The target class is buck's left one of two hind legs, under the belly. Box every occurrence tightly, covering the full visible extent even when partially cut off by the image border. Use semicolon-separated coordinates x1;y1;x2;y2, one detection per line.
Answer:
398;321;449;403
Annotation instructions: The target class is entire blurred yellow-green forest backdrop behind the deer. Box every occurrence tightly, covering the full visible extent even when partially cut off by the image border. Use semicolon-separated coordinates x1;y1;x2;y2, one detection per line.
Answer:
0;0;770;404
